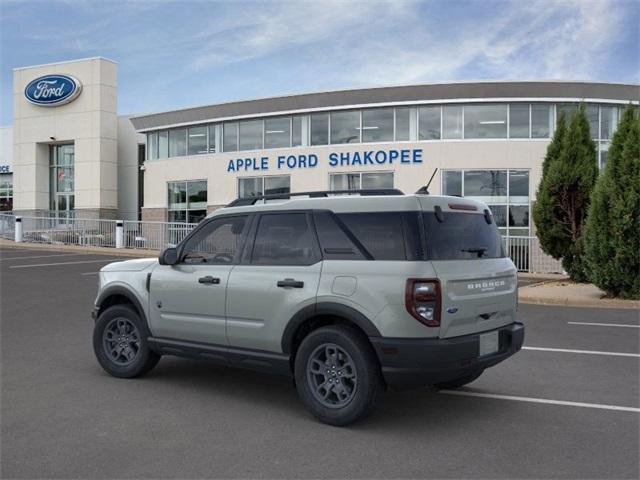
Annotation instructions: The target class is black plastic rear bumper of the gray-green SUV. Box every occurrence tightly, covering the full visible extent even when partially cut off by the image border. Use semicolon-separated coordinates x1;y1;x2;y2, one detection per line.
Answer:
369;322;524;389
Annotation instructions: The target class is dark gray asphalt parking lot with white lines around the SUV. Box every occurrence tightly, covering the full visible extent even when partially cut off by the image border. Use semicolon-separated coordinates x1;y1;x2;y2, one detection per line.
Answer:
0;247;640;478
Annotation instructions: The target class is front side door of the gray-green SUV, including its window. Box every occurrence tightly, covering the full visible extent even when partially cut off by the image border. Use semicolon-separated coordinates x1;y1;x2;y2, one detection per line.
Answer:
149;215;249;345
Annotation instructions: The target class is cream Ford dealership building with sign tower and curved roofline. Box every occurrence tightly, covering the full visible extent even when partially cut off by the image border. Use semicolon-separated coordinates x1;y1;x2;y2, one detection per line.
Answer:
0;58;640;236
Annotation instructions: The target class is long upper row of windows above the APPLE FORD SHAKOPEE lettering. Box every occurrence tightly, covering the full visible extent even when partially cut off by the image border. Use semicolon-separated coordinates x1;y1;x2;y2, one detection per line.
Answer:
147;102;622;163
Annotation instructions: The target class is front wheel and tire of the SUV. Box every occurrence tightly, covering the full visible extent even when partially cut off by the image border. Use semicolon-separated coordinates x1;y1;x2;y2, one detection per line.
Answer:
93;305;160;378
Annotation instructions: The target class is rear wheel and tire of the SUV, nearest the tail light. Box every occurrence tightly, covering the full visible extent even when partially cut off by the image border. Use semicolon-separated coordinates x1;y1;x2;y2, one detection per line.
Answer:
294;325;384;426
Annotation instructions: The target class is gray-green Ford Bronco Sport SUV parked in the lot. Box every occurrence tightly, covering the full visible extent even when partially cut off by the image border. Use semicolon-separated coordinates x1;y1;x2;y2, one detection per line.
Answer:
93;190;524;425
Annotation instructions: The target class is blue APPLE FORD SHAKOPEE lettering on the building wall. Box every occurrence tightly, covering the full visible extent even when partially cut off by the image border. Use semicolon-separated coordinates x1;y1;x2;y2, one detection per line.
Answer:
227;148;423;172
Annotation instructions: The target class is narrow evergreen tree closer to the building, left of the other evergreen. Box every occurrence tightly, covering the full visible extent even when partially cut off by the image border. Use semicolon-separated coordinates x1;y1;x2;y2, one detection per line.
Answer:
533;105;598;282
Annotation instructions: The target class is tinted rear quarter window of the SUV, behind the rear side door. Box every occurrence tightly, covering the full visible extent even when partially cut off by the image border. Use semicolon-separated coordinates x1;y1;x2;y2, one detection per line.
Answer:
338;212;407;260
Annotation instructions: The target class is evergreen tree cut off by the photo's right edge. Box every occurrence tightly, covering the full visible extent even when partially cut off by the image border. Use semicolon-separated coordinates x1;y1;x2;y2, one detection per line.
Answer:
584;106;640;298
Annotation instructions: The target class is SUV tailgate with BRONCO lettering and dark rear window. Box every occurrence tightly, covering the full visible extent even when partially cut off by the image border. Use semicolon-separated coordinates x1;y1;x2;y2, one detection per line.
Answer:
423;204;518;337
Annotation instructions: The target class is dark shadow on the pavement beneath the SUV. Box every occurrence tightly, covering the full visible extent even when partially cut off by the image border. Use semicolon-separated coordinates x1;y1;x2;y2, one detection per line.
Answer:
130;357;512;433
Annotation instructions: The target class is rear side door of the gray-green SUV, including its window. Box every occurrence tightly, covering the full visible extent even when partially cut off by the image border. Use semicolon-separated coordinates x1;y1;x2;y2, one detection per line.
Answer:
227;211;322;351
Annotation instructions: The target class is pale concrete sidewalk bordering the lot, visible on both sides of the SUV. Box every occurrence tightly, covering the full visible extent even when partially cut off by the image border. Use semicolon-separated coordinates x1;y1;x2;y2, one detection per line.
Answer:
0;239;640;310
